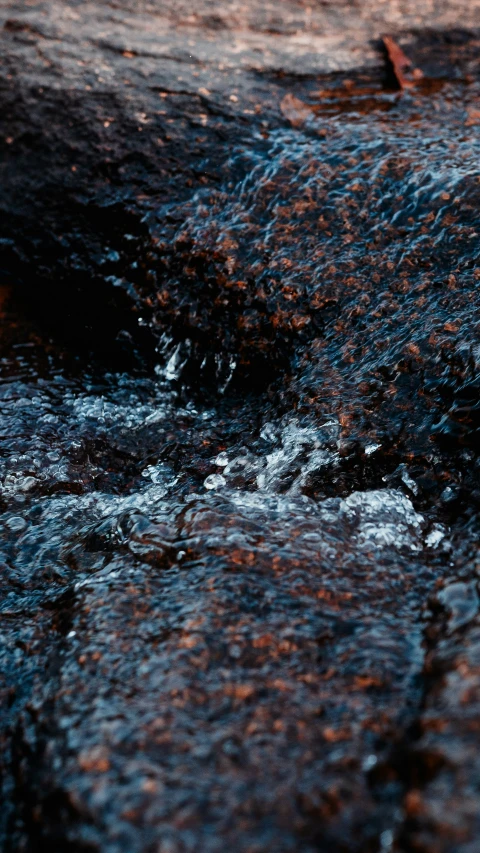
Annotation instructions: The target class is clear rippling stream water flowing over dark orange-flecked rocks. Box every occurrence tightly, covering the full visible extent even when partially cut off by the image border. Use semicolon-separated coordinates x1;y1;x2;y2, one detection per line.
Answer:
0;76;480;853
